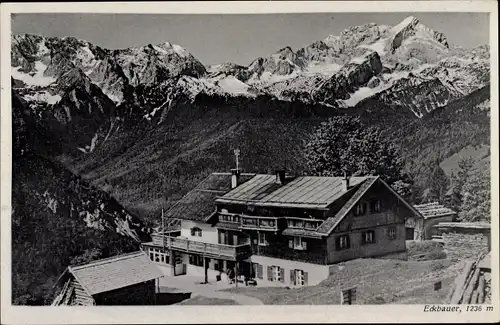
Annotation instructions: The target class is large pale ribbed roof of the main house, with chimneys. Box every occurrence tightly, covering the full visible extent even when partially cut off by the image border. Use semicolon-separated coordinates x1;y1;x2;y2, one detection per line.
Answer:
216;174;369;209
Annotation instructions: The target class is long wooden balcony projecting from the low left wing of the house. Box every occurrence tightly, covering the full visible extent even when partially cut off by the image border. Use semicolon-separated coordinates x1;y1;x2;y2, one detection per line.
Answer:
151;234;252;261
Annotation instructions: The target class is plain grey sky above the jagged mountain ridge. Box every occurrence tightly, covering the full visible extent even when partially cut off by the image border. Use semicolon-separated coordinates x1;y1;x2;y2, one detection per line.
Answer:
12;13;489;65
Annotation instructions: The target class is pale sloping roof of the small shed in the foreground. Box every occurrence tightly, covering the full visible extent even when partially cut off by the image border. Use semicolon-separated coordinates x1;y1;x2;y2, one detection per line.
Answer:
67;251;163;295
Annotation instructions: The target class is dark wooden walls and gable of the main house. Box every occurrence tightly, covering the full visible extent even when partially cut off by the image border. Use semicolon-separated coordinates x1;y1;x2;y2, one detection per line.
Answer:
217;178;415;265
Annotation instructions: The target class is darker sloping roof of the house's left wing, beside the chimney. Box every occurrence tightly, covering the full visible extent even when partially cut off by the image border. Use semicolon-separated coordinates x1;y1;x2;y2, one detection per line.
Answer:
165;173;255;221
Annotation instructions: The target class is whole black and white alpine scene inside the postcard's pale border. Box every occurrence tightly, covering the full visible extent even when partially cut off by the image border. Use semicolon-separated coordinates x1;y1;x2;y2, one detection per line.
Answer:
2;2;498;323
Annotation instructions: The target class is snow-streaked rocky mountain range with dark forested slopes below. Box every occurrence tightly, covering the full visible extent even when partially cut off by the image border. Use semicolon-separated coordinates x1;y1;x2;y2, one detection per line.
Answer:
11;17;490;304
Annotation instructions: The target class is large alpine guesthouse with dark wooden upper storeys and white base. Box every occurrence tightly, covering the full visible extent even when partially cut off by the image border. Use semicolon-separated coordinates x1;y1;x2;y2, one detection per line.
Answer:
144;173;419;285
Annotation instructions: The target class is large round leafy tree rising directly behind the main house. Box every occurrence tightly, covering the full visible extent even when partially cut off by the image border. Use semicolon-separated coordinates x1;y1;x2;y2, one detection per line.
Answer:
305;116;412;197
